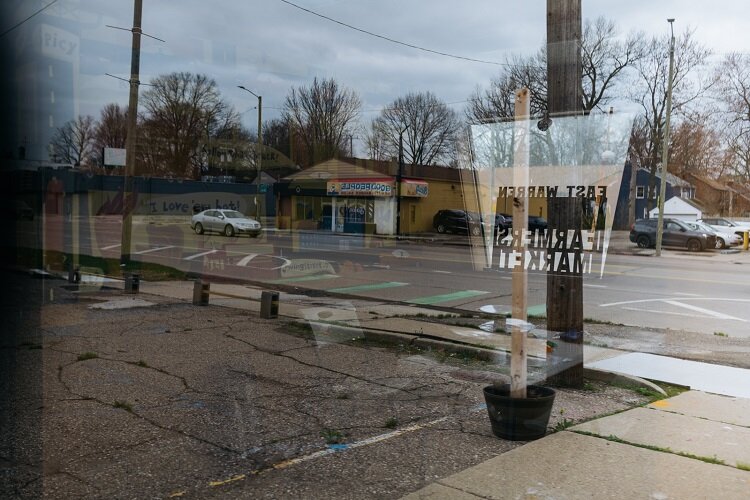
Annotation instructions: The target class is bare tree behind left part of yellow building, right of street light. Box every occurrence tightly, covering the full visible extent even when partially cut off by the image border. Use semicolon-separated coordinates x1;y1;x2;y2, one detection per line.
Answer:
282;78;361;166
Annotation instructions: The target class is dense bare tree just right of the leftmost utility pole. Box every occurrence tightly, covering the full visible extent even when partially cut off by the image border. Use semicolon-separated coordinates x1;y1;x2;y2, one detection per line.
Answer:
139;72;239;178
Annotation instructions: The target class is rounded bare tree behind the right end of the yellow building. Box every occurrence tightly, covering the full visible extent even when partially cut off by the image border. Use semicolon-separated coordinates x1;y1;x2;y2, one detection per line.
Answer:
368;92;459;165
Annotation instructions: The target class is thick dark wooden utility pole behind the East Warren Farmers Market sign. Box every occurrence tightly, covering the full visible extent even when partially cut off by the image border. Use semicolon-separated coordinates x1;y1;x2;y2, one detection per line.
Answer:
547;0;583;386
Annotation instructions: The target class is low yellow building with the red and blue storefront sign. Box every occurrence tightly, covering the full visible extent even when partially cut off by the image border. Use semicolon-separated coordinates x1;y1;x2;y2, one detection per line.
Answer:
277;158;475;234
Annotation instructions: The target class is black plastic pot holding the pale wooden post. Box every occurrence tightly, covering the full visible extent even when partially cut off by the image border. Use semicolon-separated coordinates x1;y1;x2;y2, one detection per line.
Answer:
484;384;555;441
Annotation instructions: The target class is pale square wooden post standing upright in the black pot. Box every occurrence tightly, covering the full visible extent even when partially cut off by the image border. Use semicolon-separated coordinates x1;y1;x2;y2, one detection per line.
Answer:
510;89;530;398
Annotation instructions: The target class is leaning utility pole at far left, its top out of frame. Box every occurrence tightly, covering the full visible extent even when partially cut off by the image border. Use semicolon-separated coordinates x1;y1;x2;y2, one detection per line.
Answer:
120;0;143;268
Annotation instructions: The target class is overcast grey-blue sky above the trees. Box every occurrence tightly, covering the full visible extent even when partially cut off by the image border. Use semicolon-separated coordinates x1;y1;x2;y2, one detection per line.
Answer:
11;0;750;153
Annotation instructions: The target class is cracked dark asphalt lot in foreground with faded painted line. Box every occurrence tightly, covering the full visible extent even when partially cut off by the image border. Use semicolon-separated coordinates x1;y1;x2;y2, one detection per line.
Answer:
0;280;646;498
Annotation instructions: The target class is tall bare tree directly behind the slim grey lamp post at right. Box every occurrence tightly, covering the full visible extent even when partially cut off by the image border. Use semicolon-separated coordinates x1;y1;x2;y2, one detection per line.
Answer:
631;29;715;208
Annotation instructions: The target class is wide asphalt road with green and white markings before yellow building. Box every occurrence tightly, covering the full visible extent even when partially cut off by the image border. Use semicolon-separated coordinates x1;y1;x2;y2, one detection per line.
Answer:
21;217;750;338
